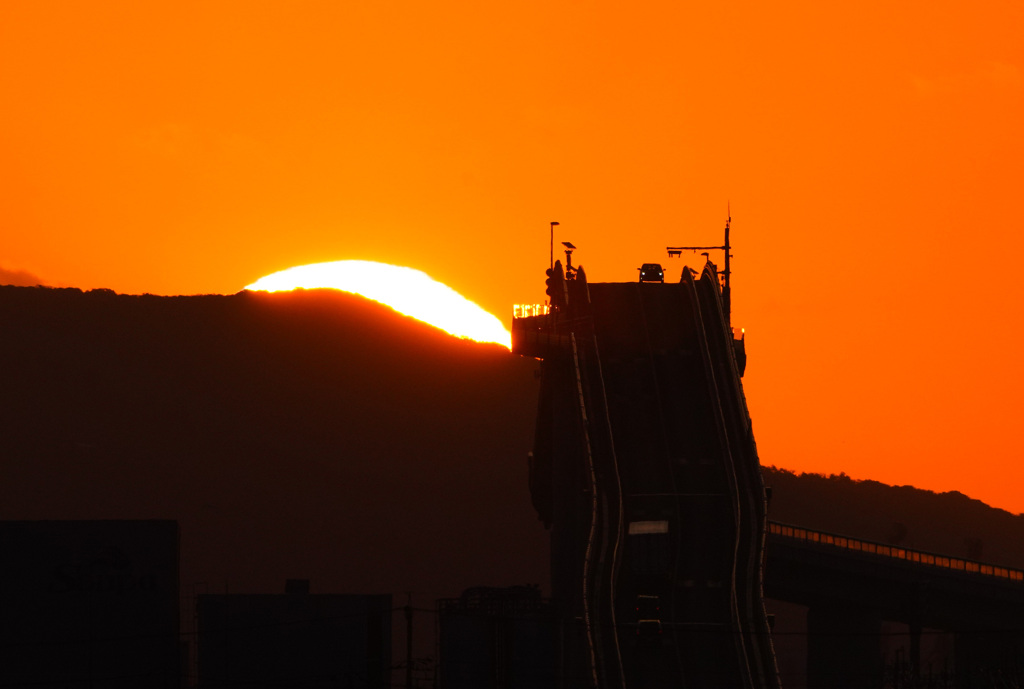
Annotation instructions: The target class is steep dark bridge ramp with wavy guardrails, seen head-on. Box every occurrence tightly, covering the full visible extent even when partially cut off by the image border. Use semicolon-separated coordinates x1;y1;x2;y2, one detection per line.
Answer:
513;264;778;689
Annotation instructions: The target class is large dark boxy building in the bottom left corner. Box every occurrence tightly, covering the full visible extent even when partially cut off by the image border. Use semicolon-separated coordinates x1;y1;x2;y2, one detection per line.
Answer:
0;520;182;689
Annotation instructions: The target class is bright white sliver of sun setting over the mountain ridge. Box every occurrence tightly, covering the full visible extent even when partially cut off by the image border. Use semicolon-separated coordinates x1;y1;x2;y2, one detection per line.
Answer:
246;261;512;349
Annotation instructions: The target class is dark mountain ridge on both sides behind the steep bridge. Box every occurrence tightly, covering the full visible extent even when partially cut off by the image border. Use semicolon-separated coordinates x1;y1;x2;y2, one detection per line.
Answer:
0;287;1024;604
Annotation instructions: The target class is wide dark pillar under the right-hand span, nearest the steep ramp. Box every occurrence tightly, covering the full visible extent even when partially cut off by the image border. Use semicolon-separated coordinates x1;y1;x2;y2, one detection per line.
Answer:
807;603;883;689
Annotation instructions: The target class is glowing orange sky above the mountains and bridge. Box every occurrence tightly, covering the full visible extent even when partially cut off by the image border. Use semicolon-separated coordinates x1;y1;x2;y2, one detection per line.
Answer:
0;0;1024;512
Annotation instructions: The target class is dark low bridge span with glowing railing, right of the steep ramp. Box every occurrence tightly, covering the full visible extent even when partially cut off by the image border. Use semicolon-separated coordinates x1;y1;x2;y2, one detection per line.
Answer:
765;522;1024;689
